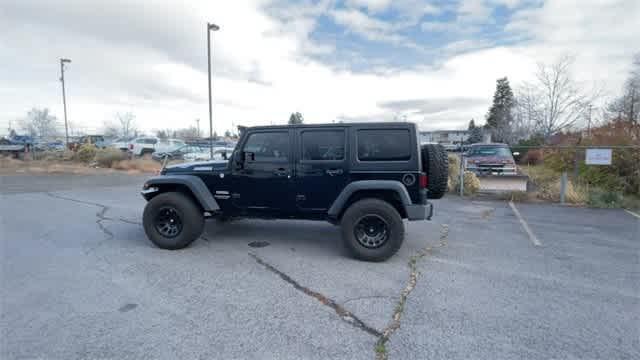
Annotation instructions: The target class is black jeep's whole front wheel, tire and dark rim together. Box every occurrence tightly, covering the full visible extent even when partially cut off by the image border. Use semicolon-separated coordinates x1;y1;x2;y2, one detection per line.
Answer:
142;192;204;250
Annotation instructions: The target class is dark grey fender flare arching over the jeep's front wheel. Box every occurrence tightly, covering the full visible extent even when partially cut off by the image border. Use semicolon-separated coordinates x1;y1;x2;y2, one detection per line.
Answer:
142;175;220;211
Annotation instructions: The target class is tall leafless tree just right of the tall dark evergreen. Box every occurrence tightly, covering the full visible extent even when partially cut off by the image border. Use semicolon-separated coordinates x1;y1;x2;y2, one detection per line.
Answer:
519;56;596;140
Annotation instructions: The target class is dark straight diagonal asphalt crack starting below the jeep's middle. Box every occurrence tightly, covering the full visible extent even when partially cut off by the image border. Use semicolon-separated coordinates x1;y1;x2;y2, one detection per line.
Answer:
249;253;382;337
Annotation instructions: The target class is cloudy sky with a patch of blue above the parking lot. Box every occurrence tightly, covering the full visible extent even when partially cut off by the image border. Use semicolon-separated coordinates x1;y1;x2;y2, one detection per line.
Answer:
0;0;640;134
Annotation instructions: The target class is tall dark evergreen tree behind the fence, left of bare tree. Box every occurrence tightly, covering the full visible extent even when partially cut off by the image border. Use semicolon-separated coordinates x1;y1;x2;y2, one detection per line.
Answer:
485;77;514;142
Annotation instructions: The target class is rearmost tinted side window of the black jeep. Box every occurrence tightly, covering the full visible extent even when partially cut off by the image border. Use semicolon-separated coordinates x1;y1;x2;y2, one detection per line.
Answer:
357;129;411;161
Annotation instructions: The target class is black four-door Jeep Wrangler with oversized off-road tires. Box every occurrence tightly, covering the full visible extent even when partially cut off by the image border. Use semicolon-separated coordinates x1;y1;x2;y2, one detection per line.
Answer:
142;123;448;261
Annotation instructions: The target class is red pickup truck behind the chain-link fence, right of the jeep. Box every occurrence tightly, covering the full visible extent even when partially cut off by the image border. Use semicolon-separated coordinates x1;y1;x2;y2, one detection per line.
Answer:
465;143;517;175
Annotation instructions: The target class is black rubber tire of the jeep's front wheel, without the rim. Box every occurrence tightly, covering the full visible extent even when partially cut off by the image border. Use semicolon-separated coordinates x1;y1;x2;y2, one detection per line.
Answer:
142;192;204;250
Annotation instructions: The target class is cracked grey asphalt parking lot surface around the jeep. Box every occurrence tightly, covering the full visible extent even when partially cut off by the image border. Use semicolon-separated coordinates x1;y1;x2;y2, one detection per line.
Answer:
0;175;640;359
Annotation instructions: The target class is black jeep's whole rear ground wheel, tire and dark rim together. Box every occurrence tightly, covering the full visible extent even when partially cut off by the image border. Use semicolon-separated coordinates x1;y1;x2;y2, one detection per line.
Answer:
340;199;404;261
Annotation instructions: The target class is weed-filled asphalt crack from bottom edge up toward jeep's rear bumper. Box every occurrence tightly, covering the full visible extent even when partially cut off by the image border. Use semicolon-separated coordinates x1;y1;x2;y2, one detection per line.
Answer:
375;224;449;360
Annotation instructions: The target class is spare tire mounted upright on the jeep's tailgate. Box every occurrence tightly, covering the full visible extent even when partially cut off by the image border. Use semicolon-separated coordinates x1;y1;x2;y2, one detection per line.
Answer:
420;144;449;199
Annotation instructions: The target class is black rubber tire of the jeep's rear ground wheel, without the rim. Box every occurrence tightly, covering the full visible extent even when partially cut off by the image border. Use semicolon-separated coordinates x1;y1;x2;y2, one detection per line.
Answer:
340;199;404;262
